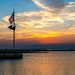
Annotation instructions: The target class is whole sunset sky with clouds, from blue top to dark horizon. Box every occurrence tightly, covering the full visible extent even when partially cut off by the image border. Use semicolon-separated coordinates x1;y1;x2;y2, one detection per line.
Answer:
0;0;75;49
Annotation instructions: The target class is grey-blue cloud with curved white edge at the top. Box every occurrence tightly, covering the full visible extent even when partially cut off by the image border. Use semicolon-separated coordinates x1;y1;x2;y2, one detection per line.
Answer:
32;0;65;13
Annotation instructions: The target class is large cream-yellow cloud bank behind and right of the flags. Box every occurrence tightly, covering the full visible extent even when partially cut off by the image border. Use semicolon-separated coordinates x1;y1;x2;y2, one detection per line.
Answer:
3;11;64;31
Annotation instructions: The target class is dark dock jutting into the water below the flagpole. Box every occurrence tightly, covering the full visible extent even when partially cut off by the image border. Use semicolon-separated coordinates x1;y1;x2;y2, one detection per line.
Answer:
0;50;23;59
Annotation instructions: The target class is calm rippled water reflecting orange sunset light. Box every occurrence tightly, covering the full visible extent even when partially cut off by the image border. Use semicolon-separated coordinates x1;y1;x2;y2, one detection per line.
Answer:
0;51;75;75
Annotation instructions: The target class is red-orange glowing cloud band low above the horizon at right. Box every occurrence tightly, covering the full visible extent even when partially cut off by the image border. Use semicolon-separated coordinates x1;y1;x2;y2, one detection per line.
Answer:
37;35;75;44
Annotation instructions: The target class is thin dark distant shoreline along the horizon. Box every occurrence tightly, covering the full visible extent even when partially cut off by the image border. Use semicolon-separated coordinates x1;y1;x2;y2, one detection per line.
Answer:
0;49;75;53
